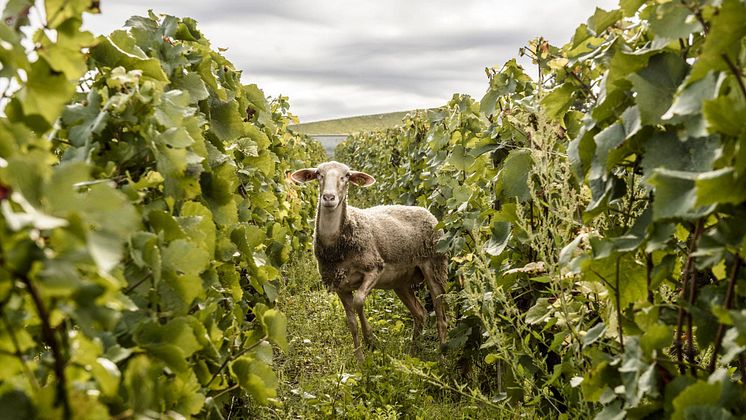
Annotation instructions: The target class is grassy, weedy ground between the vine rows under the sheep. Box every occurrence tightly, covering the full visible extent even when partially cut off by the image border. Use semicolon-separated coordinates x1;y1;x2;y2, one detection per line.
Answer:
256;253;500;419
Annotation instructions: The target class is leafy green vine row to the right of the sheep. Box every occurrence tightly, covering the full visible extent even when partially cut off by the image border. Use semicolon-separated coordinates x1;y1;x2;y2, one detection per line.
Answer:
336;0;746;419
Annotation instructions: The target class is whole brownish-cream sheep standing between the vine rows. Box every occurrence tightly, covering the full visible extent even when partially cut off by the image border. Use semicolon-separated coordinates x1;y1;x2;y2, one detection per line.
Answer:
289;161;448;362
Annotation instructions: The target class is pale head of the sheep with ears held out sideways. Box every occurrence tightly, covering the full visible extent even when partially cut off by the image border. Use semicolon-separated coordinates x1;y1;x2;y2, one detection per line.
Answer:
289;161;376;210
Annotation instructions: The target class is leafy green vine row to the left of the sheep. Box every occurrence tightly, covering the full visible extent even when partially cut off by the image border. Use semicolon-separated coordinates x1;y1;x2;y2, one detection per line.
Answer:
0;0;325;419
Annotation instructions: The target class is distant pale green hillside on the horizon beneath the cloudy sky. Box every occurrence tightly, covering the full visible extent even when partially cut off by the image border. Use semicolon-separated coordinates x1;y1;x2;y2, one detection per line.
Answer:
289;111;411;136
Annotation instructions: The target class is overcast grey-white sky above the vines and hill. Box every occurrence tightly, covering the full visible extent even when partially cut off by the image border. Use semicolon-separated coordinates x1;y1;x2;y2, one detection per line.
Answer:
86;0;617;122
